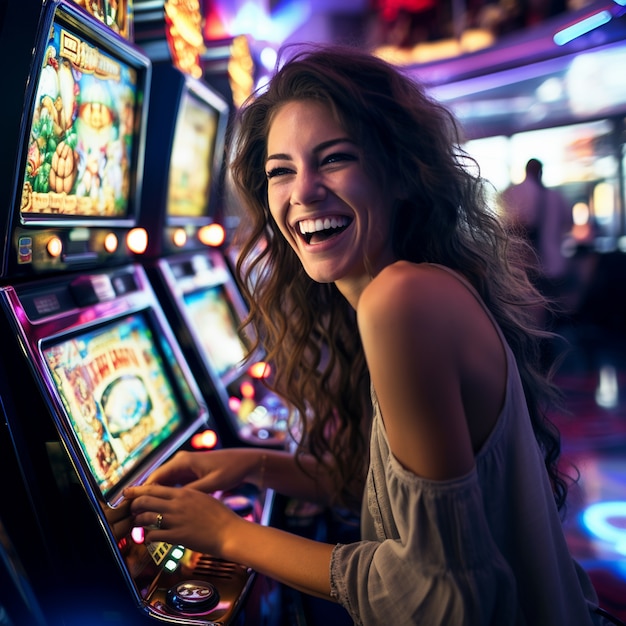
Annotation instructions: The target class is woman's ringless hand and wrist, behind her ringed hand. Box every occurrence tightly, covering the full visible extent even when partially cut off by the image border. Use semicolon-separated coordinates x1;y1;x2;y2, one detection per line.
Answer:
146;448;262;493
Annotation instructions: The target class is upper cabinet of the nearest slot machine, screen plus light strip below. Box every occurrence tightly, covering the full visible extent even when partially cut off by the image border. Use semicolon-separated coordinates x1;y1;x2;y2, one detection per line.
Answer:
0;0;151;284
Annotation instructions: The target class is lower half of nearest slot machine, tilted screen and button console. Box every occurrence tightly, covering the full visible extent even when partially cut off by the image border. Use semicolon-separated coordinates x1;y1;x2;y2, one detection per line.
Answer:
0;265;276;626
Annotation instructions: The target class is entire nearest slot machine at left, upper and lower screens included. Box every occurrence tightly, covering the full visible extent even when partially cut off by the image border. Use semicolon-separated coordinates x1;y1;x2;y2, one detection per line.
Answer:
0;0;269;626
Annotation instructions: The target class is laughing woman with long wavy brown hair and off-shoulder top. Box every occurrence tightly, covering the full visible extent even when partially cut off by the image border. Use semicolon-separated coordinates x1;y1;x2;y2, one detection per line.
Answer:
126;47;604;626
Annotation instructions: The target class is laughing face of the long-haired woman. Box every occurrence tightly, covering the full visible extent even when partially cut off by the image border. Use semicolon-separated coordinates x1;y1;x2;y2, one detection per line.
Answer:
265;100;394;292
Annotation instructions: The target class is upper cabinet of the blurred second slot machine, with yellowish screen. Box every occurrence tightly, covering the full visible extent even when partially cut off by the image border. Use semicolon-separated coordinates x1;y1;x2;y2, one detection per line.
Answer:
139;64;230;258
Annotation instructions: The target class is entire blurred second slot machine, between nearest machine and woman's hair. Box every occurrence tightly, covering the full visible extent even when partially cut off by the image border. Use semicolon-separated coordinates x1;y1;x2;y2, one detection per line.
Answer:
140;64;289;448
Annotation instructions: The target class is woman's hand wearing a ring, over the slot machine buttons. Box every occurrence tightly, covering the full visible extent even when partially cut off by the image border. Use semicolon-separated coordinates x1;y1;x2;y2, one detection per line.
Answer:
124;480;243;558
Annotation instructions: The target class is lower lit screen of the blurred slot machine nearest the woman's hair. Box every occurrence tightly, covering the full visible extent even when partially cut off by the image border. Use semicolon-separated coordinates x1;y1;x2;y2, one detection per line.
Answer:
184;286;247;376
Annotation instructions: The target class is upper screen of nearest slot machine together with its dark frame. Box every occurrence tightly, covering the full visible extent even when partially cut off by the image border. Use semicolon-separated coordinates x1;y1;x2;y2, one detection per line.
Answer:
16;3;150;224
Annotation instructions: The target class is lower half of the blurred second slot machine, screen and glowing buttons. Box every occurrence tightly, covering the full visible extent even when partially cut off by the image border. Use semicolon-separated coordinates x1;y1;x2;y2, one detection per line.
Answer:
150;250;290;448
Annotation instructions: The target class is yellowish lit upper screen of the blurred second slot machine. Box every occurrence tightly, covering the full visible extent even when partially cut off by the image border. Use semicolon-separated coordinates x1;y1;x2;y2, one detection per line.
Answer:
167;91;218;217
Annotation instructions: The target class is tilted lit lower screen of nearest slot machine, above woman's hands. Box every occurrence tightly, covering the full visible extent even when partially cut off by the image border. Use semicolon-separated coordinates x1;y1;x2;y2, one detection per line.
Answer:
43;314;183;496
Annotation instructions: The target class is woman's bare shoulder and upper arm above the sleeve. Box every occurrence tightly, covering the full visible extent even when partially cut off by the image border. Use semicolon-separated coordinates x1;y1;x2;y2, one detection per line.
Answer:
357;263;472;480
